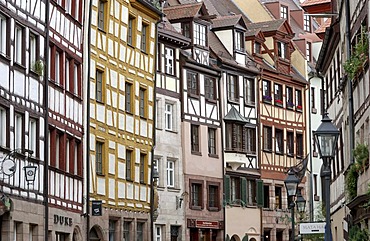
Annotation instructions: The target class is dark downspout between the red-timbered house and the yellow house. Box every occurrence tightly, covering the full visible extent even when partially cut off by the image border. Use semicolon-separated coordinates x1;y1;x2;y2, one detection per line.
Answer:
85;0;92;240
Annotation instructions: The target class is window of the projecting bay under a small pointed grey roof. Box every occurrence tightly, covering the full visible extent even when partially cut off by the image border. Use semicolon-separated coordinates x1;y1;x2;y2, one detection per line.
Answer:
226;123;244;152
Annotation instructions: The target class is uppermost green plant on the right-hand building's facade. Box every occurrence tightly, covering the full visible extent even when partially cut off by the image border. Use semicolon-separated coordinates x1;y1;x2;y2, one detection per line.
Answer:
343;28;369;80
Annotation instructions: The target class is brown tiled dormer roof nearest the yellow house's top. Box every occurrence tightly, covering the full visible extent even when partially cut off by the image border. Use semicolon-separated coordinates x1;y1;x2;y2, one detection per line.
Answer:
163;3;208;21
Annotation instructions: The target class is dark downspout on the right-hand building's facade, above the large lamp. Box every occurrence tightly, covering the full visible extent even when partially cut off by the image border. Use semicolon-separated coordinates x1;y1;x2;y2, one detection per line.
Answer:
345;0;355;164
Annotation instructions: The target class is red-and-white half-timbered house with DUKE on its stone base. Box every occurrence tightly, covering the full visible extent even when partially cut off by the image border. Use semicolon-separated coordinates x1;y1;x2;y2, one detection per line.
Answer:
46;0;85;240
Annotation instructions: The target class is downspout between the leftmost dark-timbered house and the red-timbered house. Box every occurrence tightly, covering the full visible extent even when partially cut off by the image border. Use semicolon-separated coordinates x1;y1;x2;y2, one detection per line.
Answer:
43;0;50;241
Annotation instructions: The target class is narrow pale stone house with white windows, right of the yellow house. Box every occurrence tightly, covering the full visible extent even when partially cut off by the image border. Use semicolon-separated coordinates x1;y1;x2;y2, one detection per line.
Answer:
154;17;190;240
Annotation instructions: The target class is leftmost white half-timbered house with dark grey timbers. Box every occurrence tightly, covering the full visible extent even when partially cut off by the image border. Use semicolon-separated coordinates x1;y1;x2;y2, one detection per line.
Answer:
0;1;47;240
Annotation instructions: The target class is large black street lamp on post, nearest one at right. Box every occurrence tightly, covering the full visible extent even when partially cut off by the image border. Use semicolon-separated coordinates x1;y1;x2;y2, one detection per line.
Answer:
313;113;340;241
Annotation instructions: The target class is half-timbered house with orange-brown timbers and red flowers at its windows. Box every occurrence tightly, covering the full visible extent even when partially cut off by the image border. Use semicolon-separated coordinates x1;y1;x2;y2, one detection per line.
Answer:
246;19;307;240
